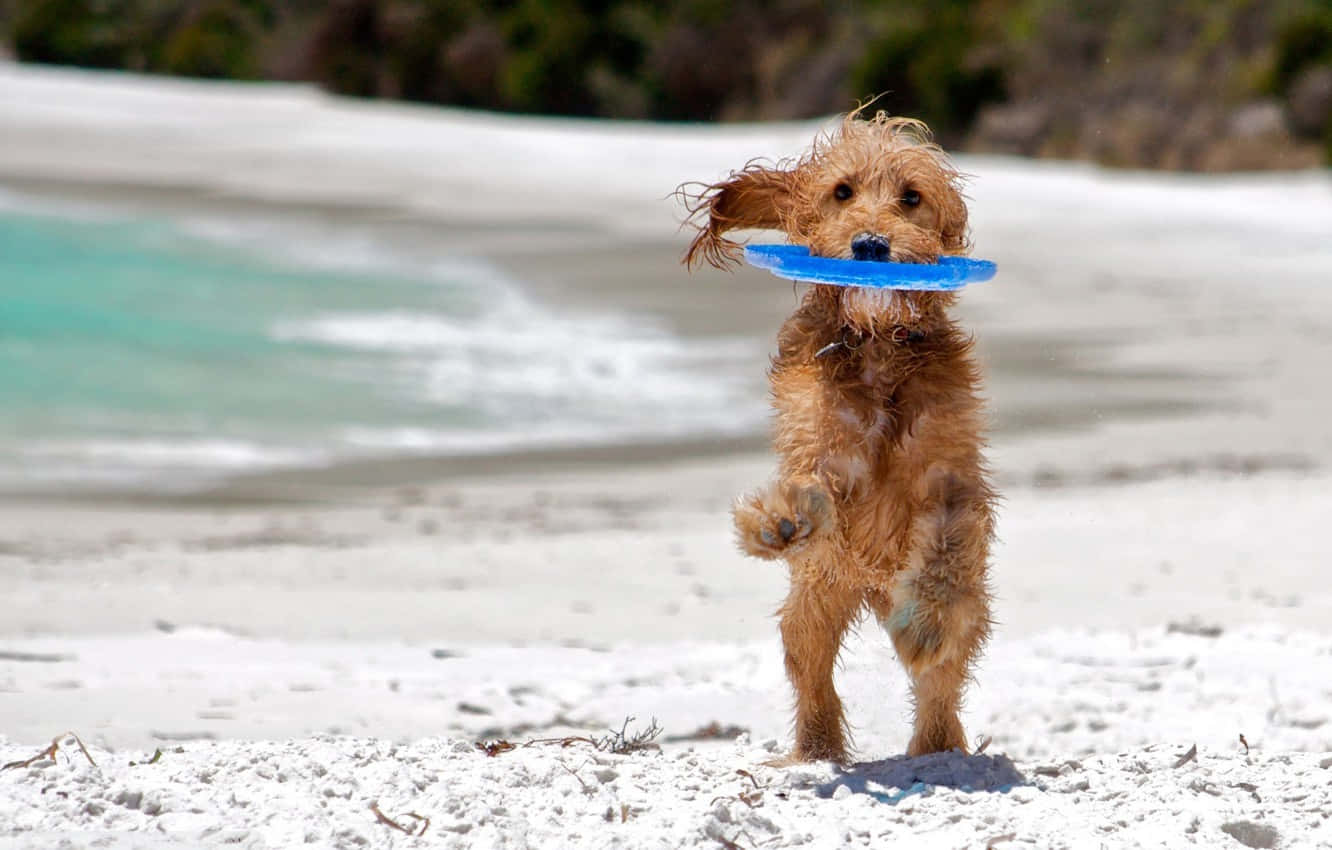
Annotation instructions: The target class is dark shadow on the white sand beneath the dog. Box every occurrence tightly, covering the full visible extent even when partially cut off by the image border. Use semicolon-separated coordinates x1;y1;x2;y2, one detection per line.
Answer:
815;751;1027;805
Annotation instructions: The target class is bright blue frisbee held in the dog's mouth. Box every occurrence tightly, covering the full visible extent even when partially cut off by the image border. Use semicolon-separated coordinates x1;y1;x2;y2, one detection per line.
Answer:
745;245;995;292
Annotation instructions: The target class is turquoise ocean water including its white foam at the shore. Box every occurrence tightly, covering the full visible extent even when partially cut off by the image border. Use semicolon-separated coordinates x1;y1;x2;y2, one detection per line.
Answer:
0;199;763;490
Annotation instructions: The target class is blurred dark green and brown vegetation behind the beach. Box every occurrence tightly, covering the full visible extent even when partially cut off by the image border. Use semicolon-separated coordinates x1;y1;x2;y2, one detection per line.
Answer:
0;0;1332;169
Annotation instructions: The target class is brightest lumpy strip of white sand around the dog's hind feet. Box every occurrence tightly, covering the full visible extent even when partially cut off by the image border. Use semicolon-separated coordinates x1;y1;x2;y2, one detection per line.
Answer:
0;628;1332;847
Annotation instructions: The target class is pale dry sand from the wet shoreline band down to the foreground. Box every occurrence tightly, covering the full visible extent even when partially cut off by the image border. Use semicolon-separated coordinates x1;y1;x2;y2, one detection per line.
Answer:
0;464;1332;847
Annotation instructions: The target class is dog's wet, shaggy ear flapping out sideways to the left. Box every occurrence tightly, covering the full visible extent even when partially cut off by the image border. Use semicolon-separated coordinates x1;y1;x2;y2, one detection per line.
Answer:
677;164;797;269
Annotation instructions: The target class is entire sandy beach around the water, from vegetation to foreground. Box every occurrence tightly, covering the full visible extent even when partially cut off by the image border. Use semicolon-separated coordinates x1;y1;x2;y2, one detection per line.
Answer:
0;64;1332;847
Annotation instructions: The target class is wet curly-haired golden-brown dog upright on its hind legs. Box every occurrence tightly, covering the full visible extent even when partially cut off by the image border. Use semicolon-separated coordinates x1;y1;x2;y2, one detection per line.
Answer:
682;112;995;761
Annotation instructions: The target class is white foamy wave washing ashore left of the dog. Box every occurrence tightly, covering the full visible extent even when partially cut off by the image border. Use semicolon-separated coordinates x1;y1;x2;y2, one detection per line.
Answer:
273;292;765;452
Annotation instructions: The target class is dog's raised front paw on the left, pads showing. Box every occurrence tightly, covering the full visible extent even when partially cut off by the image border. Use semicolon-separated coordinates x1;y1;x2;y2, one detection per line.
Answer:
733;482;833;558
